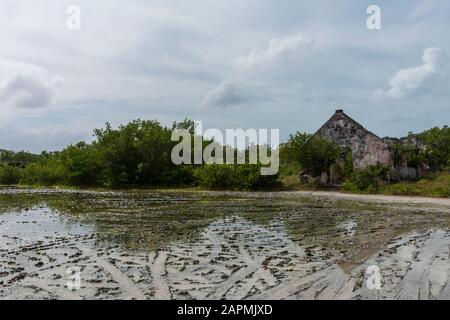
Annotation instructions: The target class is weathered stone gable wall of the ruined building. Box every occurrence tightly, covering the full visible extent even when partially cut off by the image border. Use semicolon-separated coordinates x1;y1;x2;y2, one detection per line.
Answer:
314;110;392;169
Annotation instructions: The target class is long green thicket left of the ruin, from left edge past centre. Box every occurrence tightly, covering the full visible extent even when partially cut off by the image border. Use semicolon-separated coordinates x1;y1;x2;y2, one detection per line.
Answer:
0;119;278;190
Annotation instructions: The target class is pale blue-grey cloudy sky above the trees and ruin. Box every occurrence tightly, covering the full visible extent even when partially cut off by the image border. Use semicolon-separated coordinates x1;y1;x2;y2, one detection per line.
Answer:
0;0;450;152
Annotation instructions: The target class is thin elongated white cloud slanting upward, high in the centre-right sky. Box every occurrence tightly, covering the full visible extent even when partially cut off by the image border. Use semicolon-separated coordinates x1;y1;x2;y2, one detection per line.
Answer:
234;32;313;70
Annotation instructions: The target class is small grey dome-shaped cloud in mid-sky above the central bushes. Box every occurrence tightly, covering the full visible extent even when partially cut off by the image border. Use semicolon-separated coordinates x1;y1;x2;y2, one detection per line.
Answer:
203;81;250;107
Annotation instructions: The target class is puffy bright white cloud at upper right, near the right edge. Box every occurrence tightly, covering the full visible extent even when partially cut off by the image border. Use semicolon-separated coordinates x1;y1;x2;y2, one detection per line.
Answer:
374;47;445;99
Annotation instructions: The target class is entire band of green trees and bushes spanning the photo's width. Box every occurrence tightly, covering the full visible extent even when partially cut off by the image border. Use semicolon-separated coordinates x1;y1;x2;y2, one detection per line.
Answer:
0;119;450;197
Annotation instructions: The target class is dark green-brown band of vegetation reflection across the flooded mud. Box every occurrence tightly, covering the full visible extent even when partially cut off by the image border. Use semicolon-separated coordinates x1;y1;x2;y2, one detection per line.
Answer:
0;190;450;270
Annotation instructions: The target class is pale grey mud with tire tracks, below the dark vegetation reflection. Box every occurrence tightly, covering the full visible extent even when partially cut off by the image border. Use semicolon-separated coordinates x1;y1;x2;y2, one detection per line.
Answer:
0;202;450;300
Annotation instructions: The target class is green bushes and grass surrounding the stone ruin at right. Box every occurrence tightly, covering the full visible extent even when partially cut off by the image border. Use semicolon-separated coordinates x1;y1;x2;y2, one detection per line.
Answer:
280;126;450;197
